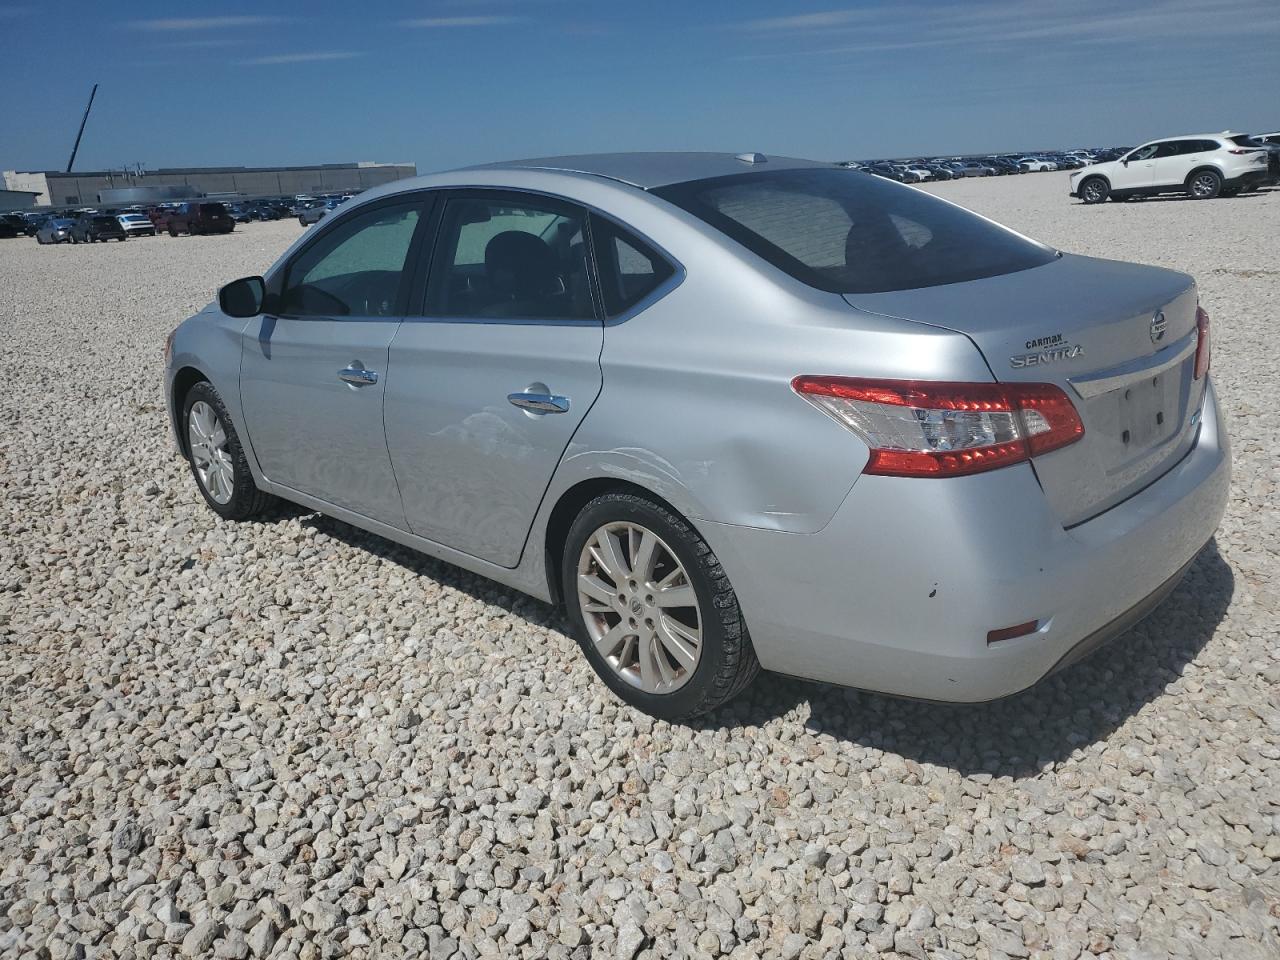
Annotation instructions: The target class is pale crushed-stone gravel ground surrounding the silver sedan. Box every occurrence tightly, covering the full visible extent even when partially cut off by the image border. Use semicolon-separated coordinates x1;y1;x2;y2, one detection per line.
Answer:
0;174;1280;960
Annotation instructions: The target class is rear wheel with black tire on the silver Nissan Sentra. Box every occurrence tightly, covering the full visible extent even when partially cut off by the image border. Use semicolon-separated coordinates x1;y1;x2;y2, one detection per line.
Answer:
561;492;760;721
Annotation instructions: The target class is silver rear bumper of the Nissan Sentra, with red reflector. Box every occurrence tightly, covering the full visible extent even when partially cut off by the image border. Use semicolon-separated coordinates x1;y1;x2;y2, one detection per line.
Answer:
699;384;1230;703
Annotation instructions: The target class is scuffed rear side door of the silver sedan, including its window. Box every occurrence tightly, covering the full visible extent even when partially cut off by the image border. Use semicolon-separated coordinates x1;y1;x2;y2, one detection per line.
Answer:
385;191;604;567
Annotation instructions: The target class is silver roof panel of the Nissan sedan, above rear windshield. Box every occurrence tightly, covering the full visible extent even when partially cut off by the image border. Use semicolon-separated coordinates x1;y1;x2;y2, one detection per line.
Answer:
463;152;835;189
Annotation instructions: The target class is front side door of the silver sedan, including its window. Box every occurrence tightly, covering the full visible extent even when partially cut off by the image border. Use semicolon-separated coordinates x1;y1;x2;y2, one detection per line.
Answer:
241;200;426;529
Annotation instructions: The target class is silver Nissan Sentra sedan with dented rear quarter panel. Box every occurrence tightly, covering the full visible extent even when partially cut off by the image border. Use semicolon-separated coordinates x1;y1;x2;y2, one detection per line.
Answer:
165;154;1229;718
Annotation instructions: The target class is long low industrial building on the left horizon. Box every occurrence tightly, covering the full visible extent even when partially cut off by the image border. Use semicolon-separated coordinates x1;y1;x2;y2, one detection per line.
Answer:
0;163;417;207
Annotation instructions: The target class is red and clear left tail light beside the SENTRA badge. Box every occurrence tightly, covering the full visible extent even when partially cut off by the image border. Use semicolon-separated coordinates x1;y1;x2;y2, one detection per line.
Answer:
791;376;1084;476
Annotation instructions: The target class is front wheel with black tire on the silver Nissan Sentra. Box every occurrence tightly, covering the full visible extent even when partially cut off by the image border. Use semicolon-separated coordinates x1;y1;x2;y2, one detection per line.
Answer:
180;380;275;520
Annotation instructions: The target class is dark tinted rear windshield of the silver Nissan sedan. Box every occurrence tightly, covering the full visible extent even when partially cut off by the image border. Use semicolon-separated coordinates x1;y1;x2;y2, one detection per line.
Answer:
654;169;1057;293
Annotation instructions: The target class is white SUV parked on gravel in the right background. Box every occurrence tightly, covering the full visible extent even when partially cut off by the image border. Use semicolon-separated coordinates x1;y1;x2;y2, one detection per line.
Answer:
1071;132;1267;204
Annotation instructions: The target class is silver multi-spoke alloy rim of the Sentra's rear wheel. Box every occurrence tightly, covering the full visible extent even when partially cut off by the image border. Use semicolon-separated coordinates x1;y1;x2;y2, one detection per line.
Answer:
576;521;703;694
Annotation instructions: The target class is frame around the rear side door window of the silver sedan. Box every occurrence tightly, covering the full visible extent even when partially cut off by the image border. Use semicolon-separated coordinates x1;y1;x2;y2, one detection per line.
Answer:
404;186;604;326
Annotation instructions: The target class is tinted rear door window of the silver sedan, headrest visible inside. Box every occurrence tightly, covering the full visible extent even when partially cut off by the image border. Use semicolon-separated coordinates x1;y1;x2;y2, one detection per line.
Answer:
426;197;595;320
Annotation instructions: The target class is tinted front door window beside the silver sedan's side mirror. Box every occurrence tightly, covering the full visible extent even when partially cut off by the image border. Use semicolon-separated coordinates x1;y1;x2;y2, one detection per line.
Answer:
280;205;419;316
